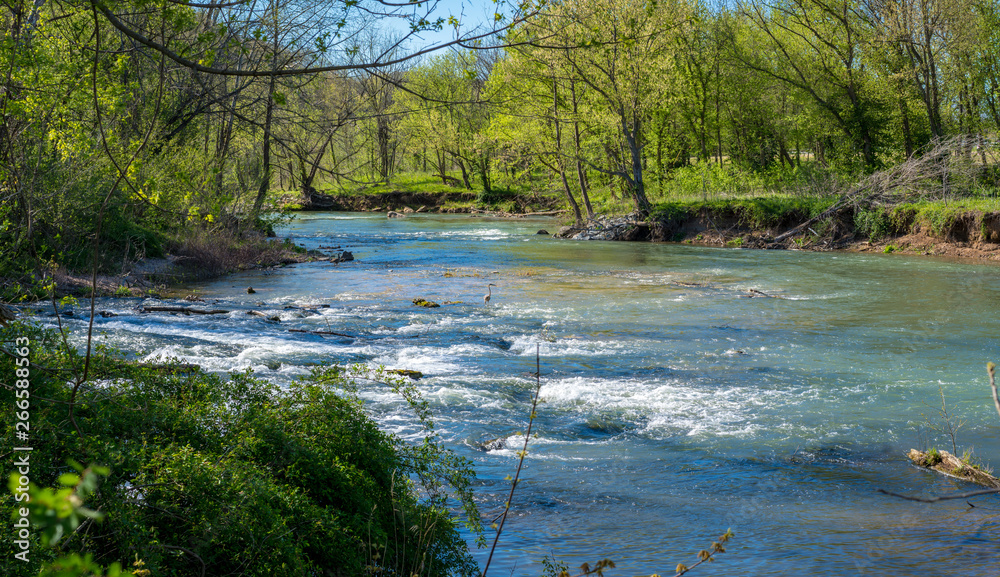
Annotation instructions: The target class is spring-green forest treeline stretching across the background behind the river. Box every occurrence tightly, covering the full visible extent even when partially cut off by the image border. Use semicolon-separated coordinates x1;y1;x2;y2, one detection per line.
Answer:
0;0;1000;280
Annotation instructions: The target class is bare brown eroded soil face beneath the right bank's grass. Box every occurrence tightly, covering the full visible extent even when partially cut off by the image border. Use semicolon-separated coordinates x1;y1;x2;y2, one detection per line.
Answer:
556;207;1000;260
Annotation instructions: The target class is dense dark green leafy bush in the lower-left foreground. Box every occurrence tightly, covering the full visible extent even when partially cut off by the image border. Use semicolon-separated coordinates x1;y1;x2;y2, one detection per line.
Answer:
0;323;478;576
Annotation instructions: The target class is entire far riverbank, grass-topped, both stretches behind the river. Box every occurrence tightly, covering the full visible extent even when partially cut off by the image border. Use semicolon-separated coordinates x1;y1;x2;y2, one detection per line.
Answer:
276;171;1000;260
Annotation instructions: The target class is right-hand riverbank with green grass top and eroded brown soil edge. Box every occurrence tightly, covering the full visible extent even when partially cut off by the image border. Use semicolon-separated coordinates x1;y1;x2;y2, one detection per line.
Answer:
556;197;1000;260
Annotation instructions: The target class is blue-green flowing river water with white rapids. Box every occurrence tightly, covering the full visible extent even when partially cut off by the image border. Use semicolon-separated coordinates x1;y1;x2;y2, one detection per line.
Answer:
56;213;1000;576
